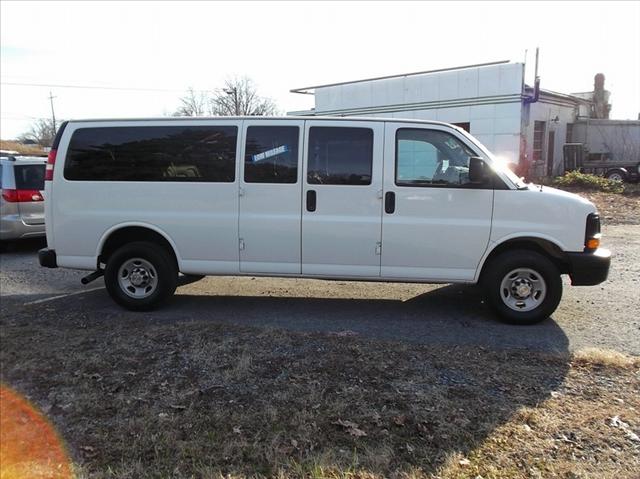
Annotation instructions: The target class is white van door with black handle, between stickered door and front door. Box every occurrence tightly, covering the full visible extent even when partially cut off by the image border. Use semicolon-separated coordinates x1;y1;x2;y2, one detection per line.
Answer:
302;120;384;277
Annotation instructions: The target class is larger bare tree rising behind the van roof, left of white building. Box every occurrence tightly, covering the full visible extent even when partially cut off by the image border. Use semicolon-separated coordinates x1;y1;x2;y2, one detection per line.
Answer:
211;77;278;116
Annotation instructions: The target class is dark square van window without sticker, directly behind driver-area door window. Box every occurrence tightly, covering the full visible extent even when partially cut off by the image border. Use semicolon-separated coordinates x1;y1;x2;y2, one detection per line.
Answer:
307;127;373;185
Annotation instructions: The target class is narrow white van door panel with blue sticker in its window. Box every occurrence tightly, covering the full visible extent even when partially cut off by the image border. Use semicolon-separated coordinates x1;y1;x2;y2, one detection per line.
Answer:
238;119;304;274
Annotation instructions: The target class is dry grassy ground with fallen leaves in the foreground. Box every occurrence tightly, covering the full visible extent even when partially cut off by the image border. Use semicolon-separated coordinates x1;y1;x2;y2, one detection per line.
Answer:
0;307;640;478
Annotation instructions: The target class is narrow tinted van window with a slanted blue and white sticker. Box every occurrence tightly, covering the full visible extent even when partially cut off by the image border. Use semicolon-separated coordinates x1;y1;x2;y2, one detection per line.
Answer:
244;126;300;183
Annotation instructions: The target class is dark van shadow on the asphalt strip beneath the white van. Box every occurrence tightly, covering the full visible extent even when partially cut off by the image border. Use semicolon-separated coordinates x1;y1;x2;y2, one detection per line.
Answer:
164;284;568;352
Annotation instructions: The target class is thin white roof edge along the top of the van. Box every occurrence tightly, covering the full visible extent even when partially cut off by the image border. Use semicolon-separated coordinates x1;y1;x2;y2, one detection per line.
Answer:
63;116;457;128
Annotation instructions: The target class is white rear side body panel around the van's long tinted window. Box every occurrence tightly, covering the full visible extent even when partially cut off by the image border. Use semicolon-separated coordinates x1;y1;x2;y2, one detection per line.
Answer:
50;120;242;274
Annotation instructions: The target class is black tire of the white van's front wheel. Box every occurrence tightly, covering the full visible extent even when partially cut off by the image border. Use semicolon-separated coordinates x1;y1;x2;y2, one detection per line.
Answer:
481;250;562;324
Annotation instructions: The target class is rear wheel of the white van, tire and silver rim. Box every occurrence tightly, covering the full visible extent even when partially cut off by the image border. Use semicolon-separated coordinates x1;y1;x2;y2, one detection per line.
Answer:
104;241;178;311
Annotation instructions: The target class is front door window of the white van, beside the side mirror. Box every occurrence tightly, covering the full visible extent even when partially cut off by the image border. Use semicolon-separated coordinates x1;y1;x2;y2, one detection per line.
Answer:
396;128;476;188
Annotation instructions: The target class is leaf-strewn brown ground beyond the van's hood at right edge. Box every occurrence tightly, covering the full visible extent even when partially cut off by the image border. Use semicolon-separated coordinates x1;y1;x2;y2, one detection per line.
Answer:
562;185;640;225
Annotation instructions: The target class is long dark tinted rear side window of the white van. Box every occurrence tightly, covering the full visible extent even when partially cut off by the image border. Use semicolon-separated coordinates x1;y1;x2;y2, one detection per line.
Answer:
64;126;238;183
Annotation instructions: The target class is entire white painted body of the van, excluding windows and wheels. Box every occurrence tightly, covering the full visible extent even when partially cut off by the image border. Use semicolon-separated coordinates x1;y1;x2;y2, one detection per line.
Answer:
45;117;596;283
